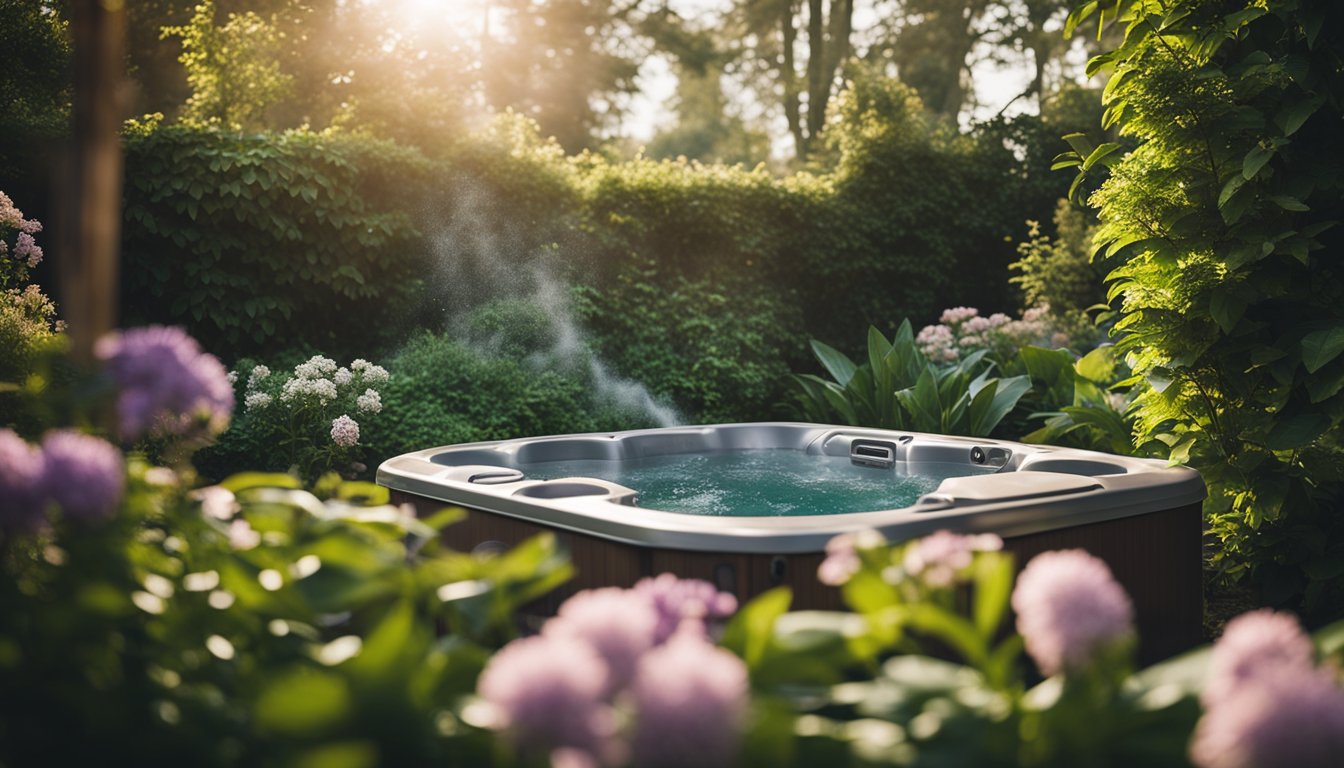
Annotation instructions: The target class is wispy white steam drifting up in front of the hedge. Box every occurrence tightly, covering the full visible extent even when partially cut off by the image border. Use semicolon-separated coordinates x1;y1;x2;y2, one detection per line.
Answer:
430;180;681;426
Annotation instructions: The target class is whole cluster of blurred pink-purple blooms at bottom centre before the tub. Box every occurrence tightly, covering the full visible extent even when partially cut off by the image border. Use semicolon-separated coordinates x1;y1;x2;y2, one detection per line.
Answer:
477;574;749;765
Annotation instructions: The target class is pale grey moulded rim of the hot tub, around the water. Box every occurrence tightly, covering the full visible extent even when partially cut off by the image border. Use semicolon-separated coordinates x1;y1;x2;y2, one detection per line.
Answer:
378;421;1206;554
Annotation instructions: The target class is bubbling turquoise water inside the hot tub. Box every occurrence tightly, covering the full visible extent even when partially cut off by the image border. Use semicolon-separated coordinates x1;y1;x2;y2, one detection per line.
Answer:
519;449;970;516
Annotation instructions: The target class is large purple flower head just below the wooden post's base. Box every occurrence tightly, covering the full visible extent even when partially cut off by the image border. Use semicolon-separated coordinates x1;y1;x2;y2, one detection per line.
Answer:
94;325;234;440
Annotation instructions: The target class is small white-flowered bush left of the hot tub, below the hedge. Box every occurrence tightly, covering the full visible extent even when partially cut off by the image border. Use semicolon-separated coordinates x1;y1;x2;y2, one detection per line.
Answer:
220;355;391;479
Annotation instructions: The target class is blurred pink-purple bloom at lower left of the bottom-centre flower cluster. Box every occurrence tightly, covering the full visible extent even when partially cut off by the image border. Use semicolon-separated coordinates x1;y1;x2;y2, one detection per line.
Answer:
477;635;614;755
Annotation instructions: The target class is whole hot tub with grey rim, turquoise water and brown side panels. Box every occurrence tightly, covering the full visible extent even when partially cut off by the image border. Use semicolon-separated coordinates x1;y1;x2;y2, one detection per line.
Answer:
378;422;1204;659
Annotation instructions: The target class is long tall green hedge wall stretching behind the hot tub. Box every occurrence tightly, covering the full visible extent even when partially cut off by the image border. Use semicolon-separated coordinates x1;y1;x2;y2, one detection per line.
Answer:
124;73;1068;421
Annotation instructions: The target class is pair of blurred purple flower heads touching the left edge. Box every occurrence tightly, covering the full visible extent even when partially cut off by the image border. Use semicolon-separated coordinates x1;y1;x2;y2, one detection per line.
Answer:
0;429;126;533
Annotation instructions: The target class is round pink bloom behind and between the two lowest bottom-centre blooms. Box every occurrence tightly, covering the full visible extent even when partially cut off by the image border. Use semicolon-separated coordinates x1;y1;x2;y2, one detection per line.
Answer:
542;586;659;694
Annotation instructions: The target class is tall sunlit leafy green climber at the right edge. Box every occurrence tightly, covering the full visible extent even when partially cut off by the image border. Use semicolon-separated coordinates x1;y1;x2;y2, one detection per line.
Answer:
1063;0;1344;615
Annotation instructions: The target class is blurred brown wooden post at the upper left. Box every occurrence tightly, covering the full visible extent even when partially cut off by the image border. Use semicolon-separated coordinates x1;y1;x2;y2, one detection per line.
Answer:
54;0;126;364
